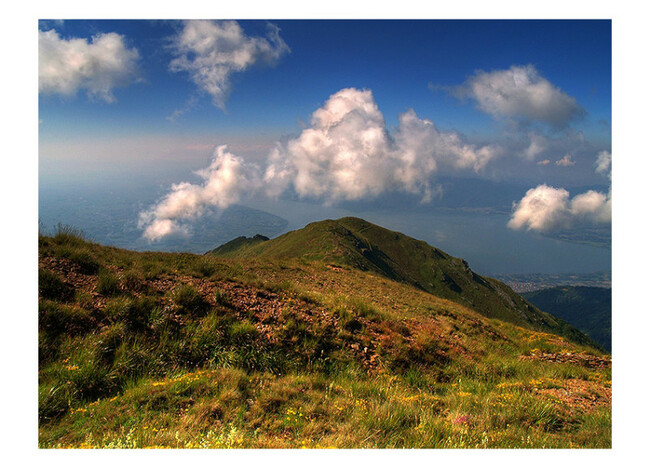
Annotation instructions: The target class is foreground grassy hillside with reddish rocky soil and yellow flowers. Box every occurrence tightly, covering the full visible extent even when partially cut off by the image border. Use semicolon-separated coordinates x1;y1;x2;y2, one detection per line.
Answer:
39;226;611;448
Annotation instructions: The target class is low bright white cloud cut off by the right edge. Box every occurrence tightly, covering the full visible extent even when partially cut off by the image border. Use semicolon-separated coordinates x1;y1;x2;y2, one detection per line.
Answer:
508;185;612;232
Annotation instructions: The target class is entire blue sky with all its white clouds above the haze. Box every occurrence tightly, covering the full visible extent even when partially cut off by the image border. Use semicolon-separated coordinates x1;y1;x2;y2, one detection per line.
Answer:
38;19;612;256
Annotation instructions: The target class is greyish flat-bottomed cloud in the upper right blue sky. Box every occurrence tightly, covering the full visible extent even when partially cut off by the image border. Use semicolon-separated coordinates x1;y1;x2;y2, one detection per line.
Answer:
455;65;584;127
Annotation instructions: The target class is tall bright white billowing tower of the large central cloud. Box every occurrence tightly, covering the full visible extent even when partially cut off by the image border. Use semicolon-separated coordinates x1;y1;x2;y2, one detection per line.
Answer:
265;88;396;200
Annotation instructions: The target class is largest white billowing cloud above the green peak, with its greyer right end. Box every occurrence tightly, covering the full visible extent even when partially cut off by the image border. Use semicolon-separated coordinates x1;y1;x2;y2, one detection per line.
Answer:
265;88;499;203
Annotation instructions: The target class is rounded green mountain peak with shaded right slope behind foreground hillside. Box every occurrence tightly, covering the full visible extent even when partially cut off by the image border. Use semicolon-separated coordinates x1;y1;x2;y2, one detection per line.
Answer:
211;218;595;345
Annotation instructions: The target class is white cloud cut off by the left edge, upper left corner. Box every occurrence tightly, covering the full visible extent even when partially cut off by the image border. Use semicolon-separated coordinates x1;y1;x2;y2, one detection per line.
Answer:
38;29;139;102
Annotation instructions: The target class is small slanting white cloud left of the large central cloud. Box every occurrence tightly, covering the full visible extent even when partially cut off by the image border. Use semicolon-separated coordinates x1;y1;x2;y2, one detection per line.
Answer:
138;145;261;241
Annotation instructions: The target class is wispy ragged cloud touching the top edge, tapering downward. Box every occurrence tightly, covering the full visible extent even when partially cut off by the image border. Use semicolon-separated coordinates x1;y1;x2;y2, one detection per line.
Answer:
170;20;289;109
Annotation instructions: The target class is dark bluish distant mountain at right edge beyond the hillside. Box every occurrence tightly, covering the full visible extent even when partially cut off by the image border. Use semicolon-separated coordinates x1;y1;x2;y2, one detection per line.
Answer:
522;286;612;351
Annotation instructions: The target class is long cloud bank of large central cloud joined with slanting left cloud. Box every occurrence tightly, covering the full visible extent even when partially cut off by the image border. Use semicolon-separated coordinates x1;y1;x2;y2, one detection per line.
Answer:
140;88;500;241
